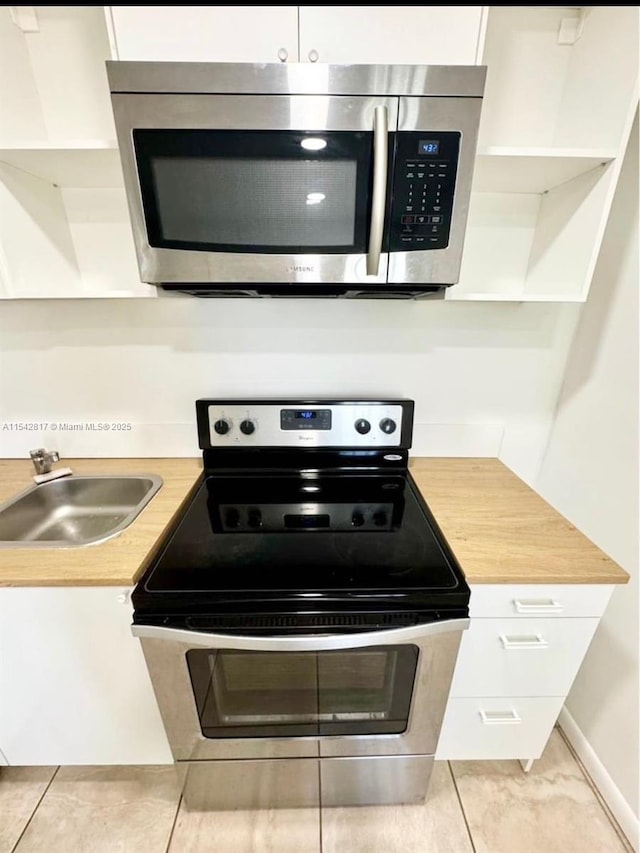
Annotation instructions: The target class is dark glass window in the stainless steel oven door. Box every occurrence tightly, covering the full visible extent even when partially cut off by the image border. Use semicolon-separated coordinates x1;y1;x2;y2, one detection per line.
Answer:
186;645;418;738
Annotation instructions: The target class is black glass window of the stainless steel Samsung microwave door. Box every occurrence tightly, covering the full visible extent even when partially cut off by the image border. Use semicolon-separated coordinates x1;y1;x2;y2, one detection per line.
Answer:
133;130;373;254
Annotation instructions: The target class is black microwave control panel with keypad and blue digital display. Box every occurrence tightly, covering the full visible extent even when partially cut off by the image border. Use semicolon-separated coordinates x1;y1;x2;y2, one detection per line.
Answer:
389;130;461;252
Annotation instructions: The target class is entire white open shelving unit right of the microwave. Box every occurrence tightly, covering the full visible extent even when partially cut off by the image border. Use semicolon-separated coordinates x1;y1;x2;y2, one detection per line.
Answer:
446;6;638;302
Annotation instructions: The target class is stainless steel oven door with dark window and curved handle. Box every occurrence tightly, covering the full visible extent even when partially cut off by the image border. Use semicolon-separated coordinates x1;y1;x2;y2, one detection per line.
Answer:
133;619;468;761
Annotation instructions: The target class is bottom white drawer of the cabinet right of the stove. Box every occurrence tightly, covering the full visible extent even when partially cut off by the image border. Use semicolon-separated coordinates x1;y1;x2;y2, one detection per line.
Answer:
436;697;564;760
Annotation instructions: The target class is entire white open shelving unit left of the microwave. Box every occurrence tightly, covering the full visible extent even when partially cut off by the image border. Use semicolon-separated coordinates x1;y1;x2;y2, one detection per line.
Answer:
0;6;149;299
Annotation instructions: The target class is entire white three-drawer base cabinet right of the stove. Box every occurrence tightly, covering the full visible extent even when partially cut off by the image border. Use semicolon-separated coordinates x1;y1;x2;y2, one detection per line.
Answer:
436;584;613;761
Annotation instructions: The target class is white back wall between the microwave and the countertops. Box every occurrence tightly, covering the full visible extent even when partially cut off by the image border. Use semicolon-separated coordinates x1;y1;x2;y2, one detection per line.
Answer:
0;298;579;479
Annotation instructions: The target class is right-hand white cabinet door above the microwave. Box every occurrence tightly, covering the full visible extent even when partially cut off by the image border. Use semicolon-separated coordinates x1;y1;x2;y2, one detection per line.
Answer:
299;6;485;65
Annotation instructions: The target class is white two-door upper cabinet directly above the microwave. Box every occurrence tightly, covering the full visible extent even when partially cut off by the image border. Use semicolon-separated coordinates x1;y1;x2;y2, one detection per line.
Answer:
110;6;485;65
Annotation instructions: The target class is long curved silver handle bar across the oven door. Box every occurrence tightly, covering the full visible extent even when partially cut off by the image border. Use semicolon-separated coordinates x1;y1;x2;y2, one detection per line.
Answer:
131;619;469;652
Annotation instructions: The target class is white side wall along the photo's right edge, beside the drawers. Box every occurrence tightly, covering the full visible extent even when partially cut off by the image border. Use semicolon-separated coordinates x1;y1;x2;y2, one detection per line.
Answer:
536;115;640;839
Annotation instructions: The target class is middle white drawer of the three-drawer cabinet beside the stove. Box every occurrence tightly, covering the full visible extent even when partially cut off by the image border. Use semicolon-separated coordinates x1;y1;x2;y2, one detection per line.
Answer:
450;619;599;696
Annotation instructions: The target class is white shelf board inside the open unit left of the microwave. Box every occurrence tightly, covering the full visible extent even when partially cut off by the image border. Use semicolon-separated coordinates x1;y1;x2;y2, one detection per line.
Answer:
0;139;123;187
